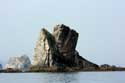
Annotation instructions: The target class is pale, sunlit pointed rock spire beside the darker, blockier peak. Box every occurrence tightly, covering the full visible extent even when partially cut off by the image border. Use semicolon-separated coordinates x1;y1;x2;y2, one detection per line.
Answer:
33;29;58;67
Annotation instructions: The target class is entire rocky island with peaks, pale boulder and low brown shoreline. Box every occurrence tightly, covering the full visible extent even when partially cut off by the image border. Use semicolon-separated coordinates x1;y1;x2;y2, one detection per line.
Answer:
0;24;125;72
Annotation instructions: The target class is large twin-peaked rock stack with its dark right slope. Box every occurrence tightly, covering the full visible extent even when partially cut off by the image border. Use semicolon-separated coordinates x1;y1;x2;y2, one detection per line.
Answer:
33;24;98;69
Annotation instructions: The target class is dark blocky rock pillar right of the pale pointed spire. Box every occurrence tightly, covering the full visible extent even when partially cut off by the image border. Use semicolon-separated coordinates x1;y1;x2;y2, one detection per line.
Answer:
53;24;78;66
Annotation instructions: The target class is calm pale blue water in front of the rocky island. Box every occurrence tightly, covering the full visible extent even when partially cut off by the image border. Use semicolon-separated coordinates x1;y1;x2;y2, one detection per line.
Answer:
0;72;125;83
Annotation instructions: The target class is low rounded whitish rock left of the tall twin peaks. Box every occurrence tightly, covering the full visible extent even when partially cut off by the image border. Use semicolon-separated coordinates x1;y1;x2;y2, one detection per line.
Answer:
5;55;31;71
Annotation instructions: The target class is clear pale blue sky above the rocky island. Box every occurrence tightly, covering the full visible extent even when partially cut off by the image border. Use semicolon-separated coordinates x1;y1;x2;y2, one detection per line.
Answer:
0;0;125;66
